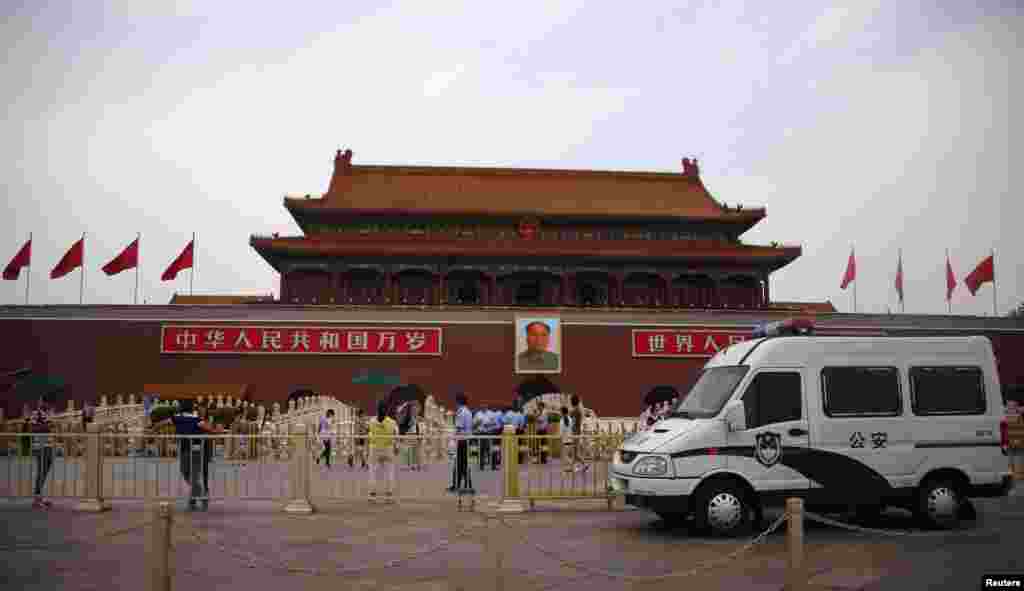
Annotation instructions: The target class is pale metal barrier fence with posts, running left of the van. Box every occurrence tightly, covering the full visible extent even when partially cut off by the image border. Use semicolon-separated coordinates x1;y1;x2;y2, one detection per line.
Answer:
0;424;623;512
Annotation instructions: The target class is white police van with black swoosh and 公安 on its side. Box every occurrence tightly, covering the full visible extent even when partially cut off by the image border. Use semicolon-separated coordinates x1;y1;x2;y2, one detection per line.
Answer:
608;319;1013;535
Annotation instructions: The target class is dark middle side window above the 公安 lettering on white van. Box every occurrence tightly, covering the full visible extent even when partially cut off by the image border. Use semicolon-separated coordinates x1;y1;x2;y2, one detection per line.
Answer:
821;367;903;417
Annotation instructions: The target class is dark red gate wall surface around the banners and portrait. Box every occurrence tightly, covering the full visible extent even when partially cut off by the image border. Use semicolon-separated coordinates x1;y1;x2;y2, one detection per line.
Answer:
0;319;1024;416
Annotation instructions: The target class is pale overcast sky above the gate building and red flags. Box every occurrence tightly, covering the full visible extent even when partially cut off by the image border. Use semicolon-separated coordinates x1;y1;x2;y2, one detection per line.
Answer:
0;0;1024;314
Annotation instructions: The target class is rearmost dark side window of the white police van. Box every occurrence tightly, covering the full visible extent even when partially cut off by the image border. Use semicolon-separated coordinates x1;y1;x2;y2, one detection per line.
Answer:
910;367;985;416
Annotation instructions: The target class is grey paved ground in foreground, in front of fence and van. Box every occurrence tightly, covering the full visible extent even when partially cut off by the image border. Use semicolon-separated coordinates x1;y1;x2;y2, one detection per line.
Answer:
0;483;1024;591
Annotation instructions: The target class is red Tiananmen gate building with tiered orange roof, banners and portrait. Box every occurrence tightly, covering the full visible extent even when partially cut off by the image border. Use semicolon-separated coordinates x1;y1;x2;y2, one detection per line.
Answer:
0;151;1024;416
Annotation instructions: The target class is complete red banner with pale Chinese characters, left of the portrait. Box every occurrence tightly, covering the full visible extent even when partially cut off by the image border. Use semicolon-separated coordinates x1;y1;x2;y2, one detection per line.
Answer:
160;325;442;355
